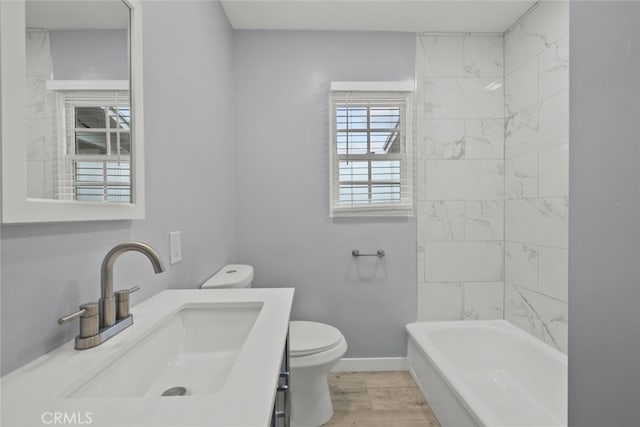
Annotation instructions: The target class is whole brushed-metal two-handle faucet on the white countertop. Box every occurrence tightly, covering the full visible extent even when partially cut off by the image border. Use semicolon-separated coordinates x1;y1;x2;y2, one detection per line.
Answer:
58;242;164;350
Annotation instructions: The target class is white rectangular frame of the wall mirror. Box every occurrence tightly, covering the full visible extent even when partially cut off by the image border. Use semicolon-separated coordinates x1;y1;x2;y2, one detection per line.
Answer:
0;0;145;224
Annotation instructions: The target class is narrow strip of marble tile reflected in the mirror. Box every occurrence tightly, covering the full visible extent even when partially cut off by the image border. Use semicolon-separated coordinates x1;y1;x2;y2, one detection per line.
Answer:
25;29;56;199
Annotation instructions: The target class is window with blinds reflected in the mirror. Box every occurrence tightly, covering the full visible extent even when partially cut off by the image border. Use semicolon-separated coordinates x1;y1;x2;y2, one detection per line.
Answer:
56;90;131;203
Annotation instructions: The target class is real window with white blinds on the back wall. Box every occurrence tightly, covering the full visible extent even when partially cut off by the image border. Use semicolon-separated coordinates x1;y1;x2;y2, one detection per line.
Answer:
330;82;413;216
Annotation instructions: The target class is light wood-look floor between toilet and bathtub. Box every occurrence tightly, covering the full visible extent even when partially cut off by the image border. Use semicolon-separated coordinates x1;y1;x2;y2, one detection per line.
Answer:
324;371;440;427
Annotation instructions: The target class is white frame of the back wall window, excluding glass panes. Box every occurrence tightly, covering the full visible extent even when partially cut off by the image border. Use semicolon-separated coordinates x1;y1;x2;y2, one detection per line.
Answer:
329;81;415;217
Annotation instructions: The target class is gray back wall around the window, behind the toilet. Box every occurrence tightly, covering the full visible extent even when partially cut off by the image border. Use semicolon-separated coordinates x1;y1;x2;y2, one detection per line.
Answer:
235;31;416;357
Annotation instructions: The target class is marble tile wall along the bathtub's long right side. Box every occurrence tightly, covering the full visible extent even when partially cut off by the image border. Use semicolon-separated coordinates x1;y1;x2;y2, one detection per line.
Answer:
504;2;569;352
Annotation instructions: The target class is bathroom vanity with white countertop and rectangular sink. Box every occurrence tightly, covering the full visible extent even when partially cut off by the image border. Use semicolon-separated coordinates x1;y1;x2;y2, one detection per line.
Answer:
1;288;294;427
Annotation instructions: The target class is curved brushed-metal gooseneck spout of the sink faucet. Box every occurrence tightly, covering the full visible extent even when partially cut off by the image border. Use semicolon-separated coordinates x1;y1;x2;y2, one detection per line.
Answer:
100;242;164;328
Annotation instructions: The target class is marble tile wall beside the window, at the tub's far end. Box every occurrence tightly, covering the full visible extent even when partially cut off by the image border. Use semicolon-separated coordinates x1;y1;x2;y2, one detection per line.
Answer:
416;35;505;320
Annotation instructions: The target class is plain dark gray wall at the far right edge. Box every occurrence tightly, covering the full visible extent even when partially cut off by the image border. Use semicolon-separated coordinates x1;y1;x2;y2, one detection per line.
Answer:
569;1;640;426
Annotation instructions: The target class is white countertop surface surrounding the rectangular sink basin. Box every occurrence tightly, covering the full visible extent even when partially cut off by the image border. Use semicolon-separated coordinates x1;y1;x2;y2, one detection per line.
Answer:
0;288;294;427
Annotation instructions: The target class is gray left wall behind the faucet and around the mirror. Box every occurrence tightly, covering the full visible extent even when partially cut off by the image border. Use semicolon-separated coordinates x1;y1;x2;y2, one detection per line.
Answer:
1;1;234;374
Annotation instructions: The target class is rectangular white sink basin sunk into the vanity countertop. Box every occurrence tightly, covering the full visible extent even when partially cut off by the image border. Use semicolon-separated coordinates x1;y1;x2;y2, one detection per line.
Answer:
68;303;263;398
